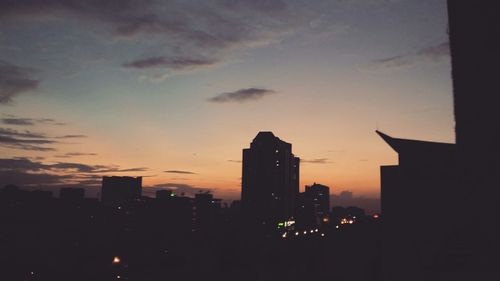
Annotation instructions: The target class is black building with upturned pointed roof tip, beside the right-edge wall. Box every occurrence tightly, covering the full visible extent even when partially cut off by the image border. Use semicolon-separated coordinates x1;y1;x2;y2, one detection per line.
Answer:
377;131;457;280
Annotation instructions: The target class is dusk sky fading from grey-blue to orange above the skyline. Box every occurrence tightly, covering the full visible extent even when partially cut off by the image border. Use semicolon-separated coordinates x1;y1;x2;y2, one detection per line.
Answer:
0;0;454;206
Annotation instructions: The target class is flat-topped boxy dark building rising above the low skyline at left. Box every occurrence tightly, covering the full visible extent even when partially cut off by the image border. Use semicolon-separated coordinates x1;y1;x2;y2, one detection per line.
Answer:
101;176;142;204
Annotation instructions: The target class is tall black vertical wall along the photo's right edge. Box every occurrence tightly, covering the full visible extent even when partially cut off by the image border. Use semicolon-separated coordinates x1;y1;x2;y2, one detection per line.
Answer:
448;0;500;274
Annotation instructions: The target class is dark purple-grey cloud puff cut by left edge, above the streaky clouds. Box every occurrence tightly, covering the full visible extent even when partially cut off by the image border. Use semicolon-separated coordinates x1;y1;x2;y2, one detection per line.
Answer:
0;60;40;104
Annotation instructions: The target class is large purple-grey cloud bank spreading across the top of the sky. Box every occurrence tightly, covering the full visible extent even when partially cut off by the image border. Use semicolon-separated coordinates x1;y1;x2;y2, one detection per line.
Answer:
0;0;317;77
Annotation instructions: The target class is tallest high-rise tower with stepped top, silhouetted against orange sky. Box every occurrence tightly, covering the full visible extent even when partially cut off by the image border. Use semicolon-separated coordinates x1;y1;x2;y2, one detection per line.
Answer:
241;132;300;226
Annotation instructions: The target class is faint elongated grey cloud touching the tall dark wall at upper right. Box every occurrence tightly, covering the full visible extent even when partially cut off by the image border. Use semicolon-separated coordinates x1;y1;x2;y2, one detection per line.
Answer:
368;42;450;69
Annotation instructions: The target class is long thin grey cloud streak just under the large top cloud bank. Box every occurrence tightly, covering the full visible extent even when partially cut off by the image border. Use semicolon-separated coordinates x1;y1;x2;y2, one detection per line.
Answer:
123;56;217;70
